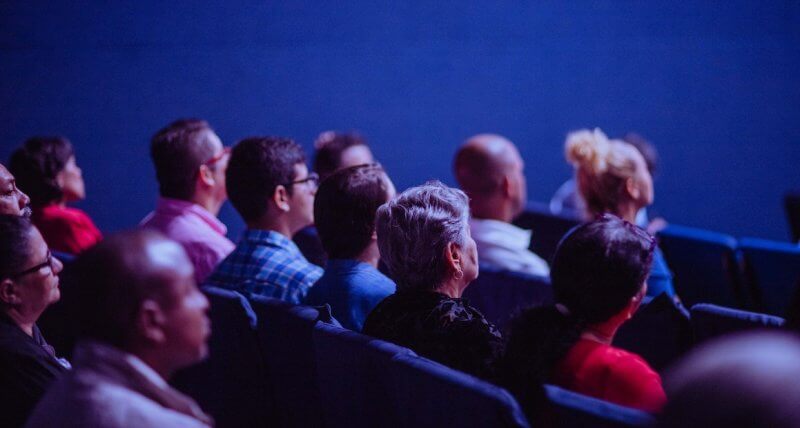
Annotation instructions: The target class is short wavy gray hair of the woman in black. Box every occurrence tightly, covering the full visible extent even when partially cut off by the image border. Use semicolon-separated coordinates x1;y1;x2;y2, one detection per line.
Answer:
375;181;469;290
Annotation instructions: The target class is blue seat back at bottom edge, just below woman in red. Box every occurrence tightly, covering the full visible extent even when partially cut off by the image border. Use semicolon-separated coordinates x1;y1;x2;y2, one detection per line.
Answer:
544;385;655;428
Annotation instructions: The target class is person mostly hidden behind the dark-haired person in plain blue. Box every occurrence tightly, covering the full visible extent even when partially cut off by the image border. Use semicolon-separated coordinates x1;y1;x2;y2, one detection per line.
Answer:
292;131;375;266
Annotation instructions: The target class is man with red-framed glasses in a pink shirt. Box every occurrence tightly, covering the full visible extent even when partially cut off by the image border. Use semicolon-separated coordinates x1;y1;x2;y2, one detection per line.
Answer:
140;119;234;283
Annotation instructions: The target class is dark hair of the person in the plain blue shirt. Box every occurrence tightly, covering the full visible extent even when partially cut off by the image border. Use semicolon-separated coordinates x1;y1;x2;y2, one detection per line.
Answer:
314;164;389;259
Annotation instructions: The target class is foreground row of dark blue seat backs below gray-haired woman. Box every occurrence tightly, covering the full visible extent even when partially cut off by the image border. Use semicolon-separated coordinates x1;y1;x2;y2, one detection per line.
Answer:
173;287;664;427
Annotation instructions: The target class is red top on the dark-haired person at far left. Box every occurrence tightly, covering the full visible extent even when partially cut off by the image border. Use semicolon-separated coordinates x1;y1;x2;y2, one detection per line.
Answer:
31;205;103;254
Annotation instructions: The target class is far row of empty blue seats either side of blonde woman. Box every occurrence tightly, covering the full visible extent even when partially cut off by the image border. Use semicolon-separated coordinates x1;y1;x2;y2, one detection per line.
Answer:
515;202;800;315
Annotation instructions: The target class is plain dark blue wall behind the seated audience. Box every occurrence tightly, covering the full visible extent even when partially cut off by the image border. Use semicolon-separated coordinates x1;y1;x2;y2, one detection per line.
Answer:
0;0;800;239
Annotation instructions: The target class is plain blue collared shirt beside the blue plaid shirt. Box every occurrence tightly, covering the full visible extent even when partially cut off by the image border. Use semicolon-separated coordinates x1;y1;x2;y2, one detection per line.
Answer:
305;259;396;331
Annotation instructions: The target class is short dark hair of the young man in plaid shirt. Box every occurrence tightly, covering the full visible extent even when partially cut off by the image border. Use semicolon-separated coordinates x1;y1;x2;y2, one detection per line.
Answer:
225;137;306;221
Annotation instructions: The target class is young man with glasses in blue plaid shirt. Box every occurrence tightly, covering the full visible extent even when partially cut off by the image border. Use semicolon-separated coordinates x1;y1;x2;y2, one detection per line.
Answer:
206;137;322;304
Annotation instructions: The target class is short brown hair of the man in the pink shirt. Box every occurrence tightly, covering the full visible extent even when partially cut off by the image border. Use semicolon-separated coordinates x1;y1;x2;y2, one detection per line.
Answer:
150;119;214;200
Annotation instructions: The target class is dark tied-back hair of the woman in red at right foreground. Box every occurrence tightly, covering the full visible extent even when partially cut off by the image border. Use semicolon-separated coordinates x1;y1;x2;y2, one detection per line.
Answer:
500;214;656;413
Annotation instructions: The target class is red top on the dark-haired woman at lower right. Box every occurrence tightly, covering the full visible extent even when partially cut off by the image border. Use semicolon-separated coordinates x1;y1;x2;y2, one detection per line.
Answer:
553;339;667;412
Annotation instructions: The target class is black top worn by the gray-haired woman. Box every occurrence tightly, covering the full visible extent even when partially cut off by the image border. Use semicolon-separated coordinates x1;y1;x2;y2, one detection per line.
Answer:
364;291;503;380
